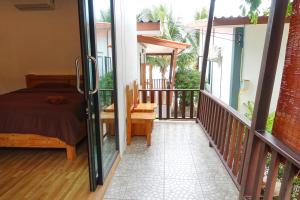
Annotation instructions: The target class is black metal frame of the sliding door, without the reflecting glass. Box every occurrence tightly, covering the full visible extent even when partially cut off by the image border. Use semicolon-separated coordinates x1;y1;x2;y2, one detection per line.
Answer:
77;0;120;191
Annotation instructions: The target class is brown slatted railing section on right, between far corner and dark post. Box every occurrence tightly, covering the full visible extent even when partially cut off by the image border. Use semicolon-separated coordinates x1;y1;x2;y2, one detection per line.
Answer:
199;91;250;188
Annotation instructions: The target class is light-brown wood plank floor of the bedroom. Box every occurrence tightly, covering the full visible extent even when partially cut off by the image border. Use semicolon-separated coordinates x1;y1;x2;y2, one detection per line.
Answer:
0;141;116;200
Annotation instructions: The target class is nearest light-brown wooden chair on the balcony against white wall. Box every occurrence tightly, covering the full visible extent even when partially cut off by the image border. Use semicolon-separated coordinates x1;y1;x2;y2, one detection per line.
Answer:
126;85;155;146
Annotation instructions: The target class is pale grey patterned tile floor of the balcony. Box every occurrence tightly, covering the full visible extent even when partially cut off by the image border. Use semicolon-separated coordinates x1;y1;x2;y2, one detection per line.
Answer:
105;122;238;200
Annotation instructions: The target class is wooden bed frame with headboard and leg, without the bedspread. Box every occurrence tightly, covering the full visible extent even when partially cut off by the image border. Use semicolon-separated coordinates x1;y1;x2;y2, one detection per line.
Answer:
0;74;86;160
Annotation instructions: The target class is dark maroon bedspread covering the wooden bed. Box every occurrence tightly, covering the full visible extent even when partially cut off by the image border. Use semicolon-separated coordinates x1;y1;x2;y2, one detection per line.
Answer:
0;88;85;145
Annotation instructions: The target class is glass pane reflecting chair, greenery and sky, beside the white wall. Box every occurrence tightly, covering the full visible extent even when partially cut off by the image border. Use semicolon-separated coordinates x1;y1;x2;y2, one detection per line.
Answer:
94;0;117;176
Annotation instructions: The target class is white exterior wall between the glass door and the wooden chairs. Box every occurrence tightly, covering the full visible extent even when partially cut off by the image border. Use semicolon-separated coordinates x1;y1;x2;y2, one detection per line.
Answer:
115;0;139;153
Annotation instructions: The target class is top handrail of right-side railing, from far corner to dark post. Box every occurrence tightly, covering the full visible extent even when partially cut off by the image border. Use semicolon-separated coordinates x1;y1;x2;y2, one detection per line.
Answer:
200;90;251;128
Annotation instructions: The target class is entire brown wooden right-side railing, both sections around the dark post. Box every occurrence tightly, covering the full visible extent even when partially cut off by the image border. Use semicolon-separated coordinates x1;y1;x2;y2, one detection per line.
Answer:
198;91;300;199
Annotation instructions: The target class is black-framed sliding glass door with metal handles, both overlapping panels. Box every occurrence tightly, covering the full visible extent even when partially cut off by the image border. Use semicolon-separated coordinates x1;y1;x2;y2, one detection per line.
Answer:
76;0;119;191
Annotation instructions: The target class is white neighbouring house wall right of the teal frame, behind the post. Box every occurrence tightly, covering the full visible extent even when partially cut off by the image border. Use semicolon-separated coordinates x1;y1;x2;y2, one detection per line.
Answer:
239;24;289;113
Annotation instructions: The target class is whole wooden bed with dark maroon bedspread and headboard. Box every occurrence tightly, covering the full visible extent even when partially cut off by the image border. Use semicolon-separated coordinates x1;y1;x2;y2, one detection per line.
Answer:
0;74;86;160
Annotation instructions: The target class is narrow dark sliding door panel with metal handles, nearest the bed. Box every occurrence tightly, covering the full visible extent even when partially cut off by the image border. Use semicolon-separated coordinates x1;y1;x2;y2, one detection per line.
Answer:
76;0;103;191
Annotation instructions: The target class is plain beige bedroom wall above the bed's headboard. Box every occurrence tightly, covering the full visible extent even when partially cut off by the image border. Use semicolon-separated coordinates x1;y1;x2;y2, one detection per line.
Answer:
0;0;80;94
